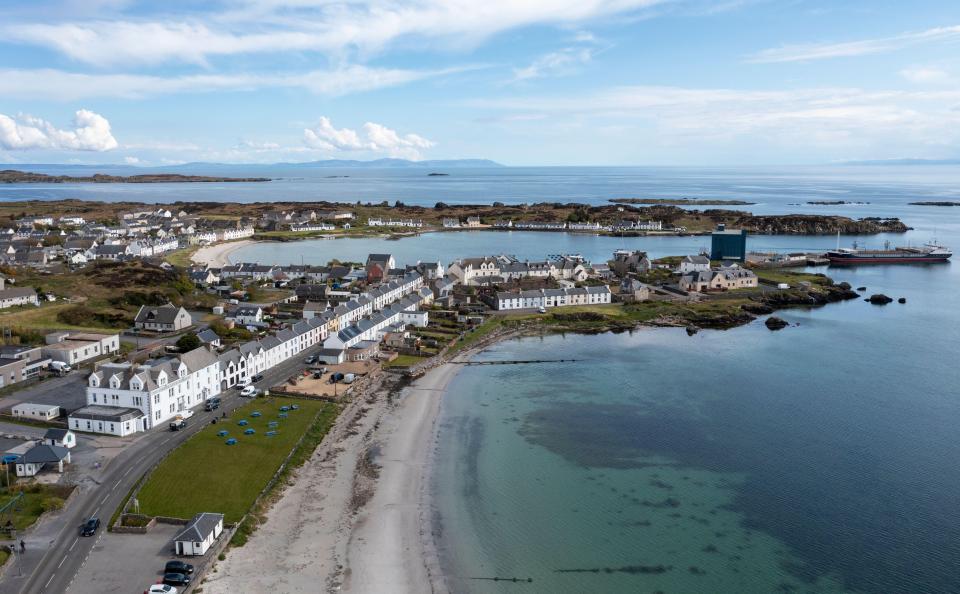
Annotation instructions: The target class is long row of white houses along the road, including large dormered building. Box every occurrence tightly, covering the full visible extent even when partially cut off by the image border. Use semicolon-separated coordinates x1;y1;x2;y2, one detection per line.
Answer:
68;273;433;436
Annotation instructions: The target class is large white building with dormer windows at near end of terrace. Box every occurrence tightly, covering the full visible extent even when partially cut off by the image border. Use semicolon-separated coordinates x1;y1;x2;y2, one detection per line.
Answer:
68;347;221;436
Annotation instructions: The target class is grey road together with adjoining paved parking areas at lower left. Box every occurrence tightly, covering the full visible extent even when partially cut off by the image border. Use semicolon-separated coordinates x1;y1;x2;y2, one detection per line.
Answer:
0;346;330;594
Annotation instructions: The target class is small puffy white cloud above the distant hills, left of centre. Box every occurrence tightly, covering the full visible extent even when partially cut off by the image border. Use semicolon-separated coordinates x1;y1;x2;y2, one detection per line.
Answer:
303;117;435;159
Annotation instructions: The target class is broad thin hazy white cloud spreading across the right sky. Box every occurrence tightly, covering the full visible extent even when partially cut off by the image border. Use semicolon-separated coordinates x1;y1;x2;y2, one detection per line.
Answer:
469;86;960;153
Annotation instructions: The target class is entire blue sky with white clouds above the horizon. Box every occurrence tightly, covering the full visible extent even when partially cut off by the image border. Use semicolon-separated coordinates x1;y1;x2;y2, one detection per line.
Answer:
0;0;960;167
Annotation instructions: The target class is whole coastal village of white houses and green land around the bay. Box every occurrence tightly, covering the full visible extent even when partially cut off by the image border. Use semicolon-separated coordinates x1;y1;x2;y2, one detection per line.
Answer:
0;201;884;588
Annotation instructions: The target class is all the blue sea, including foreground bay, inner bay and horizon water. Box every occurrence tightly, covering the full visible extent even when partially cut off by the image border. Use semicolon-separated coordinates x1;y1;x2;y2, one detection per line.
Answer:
0;166;960;594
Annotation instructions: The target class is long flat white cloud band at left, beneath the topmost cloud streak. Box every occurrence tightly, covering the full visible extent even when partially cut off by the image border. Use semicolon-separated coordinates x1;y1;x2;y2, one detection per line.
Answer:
0;65;468;101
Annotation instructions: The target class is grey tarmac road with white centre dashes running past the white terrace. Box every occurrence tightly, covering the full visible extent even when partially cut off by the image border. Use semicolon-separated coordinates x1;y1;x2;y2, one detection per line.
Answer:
0;347;319;594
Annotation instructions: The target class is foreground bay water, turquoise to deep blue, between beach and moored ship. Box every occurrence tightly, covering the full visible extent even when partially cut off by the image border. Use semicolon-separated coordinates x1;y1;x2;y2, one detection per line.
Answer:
433;251;960;593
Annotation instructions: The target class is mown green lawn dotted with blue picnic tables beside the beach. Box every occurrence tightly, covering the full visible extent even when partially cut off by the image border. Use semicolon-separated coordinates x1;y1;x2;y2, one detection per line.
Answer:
137;397;337;522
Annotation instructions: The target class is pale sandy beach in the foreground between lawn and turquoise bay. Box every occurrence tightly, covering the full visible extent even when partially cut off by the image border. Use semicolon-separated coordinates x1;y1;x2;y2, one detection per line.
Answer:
203;364;460;594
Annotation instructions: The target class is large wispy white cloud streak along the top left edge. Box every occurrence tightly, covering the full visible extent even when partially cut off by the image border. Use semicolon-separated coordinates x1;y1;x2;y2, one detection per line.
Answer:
0;0;663;66
